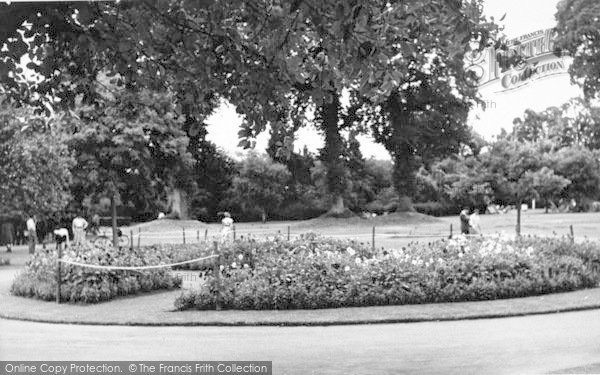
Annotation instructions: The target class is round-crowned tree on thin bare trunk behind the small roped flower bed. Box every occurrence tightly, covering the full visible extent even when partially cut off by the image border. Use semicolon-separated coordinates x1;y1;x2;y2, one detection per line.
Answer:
69;90;192;246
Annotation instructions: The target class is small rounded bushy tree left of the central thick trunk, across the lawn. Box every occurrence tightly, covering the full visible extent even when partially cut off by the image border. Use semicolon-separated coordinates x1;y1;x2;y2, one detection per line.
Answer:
229;153;291;222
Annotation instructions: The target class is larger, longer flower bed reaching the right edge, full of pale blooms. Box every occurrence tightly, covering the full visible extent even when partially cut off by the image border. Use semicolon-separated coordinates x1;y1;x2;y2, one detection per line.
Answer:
175;236;600;310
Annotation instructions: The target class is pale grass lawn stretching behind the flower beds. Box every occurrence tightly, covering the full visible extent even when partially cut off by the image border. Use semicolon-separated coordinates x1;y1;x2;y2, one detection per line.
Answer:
122;210;600;248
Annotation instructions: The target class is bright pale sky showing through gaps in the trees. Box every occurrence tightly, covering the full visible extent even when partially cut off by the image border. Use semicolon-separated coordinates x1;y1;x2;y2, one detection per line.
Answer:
207;0;580;159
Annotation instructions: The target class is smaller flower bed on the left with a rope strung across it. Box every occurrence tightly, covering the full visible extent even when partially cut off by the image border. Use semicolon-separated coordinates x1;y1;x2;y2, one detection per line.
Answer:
11;244;181;303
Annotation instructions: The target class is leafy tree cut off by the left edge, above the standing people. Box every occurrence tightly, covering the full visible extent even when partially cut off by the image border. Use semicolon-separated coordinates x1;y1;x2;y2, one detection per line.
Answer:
0;105;75;219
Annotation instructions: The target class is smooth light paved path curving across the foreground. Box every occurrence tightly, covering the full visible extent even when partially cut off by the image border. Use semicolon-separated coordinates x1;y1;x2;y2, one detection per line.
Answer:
0;310;600;375
